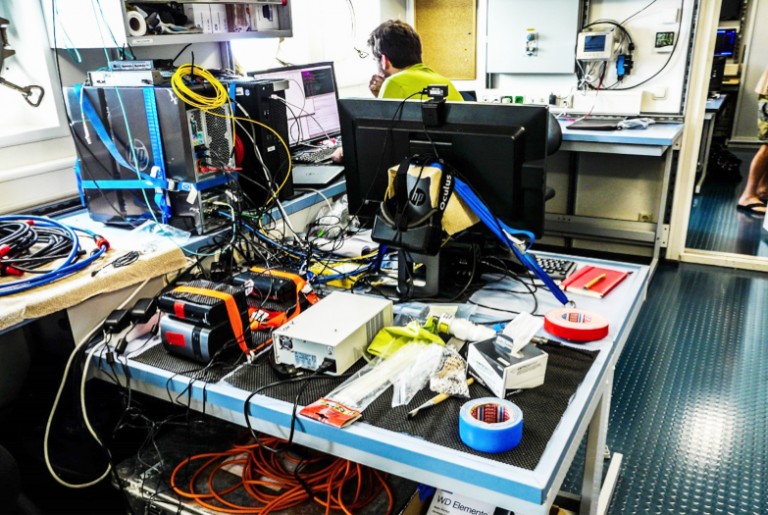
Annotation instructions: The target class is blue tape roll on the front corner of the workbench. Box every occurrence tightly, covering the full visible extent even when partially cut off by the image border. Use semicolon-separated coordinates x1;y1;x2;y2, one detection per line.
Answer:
459;397;523;452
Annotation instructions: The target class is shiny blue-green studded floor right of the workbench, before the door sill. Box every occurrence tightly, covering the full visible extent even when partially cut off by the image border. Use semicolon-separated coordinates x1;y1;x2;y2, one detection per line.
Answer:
564;264;768;515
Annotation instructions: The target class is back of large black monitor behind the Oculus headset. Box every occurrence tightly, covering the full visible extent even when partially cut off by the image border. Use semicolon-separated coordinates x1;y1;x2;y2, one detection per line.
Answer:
339;99;559;237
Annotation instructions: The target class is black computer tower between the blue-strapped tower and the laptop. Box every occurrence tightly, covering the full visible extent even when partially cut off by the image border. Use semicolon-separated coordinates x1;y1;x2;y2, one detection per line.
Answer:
229;79;294;205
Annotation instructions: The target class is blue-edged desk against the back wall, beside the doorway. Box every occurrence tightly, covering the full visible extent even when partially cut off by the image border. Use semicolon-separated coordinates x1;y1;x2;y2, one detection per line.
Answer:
545;121;683;270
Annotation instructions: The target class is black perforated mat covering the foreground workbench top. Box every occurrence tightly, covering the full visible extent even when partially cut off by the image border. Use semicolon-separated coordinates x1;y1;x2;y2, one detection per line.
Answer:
129;345;597;470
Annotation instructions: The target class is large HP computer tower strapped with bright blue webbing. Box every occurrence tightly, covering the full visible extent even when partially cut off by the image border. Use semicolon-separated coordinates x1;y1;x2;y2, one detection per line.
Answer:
65;86;234;234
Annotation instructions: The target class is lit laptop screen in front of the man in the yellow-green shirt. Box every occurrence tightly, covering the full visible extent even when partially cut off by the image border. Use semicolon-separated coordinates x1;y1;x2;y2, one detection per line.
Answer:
248;62;340;147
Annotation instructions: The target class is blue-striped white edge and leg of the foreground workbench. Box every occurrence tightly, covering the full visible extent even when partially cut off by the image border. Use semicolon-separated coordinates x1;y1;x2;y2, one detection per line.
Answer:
97;255;649;515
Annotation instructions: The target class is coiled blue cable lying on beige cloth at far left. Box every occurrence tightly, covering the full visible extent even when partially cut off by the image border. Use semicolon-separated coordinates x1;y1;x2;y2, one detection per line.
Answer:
0;215;107;296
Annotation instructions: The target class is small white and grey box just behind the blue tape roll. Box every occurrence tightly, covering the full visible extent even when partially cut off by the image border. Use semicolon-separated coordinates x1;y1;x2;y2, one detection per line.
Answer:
467;338;549;398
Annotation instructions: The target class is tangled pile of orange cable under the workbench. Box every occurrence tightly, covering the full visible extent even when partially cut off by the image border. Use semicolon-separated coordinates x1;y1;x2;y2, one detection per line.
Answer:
171;437;394;515
